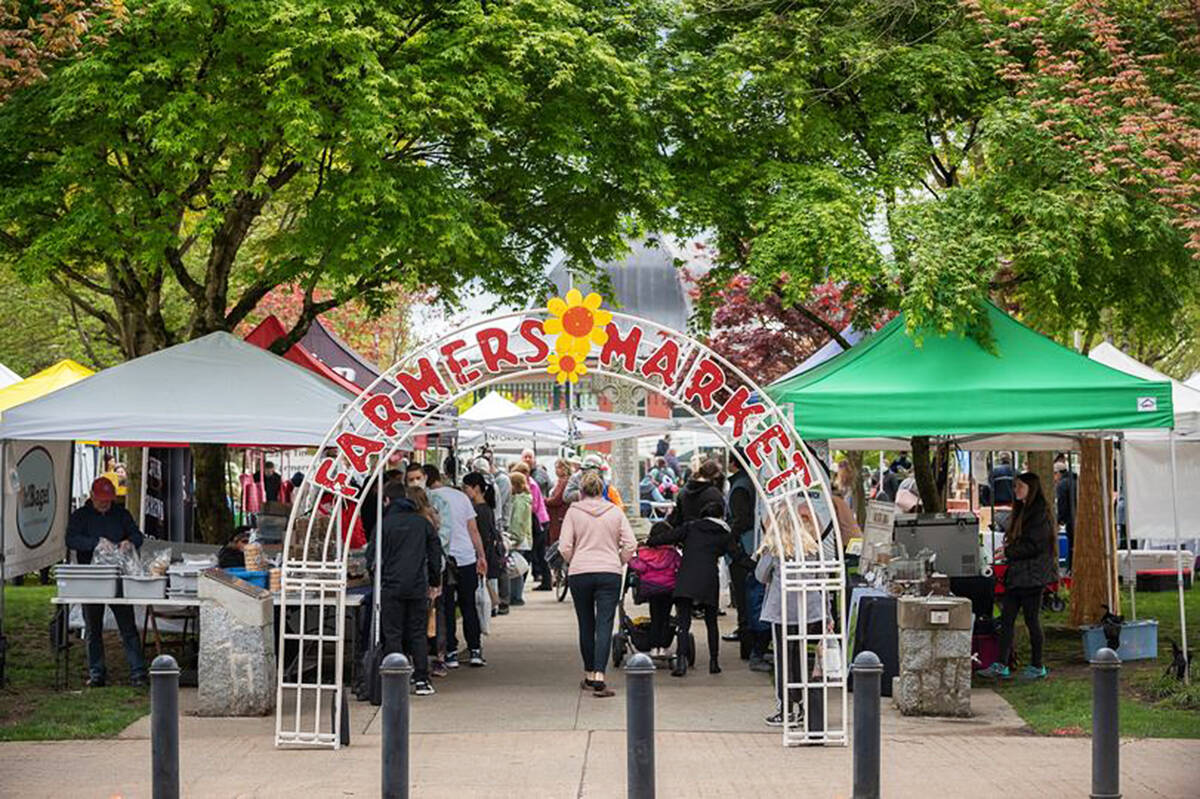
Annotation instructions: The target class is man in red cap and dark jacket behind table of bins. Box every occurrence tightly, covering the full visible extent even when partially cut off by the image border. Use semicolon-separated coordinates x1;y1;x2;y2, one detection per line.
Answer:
67;477;146;687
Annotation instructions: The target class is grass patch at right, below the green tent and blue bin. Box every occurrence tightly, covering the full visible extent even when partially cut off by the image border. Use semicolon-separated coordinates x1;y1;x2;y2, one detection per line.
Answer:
977;588;1200;738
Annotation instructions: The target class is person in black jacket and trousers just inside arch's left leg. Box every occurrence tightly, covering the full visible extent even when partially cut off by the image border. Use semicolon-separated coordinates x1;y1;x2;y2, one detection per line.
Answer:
367;480;442;696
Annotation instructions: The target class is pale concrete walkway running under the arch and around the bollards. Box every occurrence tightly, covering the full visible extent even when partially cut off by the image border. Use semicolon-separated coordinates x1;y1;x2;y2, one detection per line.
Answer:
0;583;1200;799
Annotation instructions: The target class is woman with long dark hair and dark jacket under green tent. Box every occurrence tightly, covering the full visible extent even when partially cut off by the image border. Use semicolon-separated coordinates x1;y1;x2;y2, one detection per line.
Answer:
982;471;1058;679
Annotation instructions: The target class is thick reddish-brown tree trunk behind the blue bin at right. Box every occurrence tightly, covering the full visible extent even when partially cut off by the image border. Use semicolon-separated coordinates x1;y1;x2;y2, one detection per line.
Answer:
1070;438;1121;625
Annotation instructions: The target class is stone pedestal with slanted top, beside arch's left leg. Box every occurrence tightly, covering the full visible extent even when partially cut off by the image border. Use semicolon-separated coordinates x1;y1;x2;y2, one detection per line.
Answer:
197;569;276;716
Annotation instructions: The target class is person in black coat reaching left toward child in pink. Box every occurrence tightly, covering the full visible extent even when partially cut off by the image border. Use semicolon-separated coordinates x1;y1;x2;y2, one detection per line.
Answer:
646;499;732;677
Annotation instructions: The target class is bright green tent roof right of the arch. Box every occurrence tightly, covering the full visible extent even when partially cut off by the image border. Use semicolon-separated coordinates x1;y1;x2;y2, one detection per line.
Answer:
767;305;1172;439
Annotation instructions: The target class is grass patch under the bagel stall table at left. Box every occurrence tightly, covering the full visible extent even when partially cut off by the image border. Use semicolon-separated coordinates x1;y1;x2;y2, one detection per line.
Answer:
0;585;150;740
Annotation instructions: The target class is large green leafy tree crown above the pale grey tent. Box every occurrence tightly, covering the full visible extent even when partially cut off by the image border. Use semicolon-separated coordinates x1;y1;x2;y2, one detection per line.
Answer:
0;0;660;358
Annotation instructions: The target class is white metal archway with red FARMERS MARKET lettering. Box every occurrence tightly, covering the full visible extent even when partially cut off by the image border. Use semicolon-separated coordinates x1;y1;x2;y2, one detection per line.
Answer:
276;304;846;749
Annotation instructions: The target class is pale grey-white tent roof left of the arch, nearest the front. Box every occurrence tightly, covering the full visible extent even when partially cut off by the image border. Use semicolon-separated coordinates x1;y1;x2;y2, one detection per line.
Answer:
0;332;354;446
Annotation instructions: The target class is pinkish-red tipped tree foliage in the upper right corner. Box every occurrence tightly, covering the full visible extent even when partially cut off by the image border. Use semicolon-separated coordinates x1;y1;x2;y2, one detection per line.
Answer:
964;0;1200;258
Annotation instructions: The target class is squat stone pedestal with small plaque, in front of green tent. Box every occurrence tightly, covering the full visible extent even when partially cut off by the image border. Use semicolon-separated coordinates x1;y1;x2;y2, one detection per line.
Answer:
893;596;973;716
